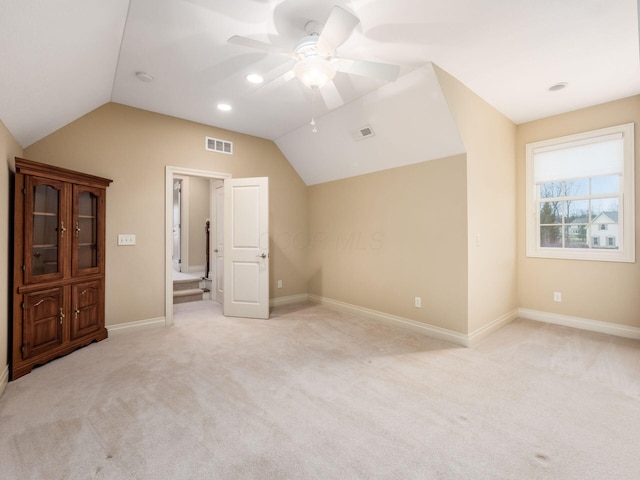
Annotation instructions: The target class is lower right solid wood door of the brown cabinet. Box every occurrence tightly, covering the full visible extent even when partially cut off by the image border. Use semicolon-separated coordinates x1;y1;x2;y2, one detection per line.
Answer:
69;280;104;341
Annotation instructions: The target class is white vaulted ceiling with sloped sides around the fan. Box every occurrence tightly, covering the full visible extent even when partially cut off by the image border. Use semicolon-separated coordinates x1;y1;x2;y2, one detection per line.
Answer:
0;0;640;183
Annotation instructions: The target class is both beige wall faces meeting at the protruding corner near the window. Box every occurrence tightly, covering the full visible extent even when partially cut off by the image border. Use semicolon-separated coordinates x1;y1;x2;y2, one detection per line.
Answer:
309;67;518;334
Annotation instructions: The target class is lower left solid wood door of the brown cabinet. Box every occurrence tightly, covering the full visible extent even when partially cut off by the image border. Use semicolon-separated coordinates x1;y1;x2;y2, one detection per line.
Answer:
22;287;65;359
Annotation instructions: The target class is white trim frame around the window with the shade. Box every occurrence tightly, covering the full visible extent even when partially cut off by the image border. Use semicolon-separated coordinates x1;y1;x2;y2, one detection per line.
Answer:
526;123;636;263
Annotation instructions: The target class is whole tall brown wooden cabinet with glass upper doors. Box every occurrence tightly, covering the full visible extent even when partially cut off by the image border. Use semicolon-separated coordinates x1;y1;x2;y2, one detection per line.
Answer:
10;158;111;379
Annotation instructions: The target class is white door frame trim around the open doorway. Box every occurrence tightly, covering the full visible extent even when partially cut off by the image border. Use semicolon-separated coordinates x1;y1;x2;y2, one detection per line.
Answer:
164;165;231;327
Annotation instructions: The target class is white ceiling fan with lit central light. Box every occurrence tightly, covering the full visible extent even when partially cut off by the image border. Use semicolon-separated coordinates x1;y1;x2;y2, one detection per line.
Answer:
228;5;400;109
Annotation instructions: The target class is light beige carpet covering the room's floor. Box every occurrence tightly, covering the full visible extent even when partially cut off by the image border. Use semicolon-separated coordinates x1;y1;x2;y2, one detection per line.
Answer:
0;301;640;480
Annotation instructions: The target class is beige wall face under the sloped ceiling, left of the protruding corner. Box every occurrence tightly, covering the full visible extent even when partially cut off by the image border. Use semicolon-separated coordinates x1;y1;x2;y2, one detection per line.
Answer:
309;155;467;333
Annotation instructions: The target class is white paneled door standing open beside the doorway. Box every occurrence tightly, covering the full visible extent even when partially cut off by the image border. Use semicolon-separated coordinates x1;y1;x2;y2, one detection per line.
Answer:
224;177;269;318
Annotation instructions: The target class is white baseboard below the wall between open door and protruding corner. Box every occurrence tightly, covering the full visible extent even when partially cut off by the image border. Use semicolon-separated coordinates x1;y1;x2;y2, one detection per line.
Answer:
309;295;470;347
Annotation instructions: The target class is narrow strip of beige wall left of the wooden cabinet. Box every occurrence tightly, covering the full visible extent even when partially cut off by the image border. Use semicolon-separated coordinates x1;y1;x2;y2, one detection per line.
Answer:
0;121;22;394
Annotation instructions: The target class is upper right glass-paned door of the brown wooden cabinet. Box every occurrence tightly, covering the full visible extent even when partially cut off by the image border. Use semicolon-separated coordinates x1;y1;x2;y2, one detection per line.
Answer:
71;185;105;277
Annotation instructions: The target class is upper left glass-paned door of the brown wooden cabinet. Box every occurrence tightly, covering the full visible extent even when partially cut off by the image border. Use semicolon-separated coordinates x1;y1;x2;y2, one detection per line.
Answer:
24;177;68;283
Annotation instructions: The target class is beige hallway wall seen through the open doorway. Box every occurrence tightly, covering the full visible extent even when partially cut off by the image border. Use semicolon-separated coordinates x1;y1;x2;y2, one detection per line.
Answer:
188;177;210;270
